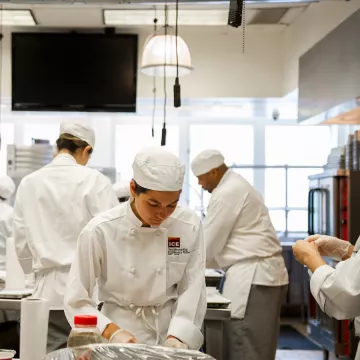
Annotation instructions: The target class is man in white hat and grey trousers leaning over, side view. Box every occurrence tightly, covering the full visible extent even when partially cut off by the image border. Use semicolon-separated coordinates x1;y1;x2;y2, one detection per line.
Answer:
191;150;288;360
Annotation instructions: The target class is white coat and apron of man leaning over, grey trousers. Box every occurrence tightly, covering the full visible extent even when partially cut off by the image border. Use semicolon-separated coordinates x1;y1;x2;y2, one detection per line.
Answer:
204;169;289;319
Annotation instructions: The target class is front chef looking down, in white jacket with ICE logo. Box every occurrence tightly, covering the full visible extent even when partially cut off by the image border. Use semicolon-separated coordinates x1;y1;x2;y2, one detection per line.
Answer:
65;147;206;349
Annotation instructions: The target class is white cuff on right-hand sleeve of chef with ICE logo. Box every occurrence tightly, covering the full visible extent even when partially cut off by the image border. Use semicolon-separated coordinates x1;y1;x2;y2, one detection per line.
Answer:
168;317;204;350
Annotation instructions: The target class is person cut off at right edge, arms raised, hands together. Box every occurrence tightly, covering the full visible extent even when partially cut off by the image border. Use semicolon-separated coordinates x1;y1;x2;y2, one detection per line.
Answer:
293;235;360;360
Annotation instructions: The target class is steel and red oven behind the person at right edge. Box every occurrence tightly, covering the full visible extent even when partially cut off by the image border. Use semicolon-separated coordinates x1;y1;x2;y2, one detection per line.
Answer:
308;171;360;356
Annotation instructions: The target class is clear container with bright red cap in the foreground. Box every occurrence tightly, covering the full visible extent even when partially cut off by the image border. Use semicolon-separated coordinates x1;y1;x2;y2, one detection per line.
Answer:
67;315;103;347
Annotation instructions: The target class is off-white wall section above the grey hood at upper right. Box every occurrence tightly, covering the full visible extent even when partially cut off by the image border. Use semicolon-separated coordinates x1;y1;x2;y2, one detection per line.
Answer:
282;0;360;94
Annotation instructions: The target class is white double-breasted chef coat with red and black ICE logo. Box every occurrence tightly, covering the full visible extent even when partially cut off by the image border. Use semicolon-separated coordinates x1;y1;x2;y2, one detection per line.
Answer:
65;201;206;349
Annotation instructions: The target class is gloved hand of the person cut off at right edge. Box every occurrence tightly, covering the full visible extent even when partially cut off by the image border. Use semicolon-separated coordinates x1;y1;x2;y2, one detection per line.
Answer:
305;235;351;261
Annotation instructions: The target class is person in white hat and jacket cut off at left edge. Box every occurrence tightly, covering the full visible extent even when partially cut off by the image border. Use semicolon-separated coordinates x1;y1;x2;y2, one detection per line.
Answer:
0;175;15;270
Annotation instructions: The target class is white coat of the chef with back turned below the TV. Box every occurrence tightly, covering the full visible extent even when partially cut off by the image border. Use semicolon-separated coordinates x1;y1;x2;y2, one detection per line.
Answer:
14;154;118;310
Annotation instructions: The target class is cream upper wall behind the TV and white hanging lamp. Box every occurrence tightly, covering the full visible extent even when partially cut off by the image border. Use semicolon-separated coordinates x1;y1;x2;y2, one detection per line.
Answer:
2;26;282;98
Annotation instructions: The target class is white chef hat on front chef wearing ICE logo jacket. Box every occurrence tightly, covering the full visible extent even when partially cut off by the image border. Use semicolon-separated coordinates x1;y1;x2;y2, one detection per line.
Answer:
133;146;185;191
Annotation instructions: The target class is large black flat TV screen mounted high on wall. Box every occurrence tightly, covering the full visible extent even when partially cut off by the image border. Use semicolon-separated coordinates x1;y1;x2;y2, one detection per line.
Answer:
12;33;138;112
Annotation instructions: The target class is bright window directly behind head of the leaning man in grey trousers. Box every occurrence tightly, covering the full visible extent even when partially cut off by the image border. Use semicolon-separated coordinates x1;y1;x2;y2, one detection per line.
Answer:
189;124;254;213
